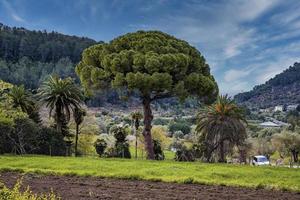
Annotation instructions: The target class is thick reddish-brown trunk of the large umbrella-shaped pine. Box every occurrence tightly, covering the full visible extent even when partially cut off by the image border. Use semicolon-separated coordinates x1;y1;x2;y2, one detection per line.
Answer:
143;98;154;160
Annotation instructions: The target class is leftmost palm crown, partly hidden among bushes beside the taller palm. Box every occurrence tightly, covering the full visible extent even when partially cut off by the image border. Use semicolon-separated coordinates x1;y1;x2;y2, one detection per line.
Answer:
8;85;41;123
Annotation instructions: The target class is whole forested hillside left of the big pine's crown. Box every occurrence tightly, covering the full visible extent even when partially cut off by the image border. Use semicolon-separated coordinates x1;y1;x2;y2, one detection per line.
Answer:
0;23;96;89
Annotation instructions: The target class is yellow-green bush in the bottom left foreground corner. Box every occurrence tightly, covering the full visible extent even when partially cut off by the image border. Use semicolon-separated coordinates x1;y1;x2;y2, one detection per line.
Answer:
0;180;61;200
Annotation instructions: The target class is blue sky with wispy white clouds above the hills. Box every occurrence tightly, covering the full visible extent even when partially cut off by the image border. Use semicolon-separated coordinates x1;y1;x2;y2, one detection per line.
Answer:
0;0;300;95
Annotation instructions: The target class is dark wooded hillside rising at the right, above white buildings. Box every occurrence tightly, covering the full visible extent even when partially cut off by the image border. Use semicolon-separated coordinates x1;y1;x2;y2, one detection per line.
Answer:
234;63;300;108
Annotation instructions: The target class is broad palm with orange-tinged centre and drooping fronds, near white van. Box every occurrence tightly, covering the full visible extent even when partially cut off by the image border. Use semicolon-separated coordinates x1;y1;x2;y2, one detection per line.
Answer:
196;95;247;162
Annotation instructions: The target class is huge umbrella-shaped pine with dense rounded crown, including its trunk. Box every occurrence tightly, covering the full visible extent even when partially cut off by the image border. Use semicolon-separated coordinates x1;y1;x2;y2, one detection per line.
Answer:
76;31;218;159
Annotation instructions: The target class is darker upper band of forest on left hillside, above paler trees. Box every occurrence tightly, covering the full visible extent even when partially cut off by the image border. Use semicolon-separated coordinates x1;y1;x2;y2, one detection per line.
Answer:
0;23;96;63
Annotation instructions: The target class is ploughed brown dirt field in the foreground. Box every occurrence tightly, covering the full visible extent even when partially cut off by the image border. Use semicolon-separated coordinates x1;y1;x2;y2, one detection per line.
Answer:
0;172;300;200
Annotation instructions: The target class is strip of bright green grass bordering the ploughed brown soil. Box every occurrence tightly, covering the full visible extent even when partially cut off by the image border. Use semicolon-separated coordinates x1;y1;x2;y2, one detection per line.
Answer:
0;156;300;191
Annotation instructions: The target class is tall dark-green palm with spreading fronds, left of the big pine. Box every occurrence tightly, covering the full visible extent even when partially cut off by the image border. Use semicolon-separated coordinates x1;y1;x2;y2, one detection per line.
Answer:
38;76;83;136
